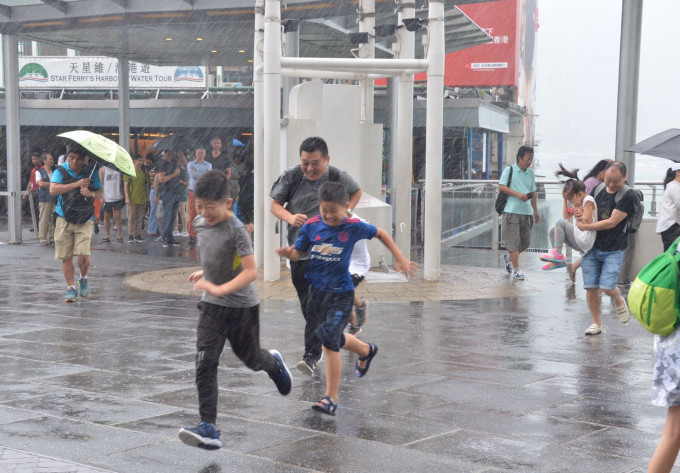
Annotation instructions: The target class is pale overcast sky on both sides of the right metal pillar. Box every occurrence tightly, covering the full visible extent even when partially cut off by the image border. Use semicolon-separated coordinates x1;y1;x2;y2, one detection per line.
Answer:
535;0;680;180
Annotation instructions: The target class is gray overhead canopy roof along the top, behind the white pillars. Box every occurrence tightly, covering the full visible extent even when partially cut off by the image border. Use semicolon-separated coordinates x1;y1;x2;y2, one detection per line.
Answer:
0;0;493;66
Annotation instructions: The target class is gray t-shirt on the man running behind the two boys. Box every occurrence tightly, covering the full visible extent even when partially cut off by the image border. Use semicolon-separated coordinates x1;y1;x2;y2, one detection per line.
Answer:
269;164;361;245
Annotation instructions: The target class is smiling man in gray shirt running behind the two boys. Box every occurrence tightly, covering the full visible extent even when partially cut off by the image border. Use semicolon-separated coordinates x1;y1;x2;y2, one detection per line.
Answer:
269;137;361;375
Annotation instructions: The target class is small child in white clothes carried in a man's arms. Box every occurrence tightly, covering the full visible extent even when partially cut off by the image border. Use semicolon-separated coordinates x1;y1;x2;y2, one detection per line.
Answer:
540;164;597;271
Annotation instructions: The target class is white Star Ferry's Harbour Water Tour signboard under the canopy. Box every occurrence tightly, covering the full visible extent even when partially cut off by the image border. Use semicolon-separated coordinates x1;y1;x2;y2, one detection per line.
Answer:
19;56;206;89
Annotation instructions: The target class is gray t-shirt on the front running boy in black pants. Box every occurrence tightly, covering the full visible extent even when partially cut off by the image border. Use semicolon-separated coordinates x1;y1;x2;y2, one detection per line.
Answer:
194;214;260;307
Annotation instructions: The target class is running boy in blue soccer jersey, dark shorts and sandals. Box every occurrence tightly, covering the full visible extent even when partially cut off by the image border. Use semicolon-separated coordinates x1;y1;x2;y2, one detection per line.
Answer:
277;181;417;415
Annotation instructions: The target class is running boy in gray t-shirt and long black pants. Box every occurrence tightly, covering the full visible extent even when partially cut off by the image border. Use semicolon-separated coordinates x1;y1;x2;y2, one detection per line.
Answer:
179;171;292;450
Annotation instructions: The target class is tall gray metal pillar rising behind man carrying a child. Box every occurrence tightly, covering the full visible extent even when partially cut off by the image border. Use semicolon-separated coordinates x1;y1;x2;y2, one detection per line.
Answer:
615;0;642;186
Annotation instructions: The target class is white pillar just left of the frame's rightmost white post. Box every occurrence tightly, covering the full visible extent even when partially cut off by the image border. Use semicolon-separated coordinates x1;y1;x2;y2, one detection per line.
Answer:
392;3;415;259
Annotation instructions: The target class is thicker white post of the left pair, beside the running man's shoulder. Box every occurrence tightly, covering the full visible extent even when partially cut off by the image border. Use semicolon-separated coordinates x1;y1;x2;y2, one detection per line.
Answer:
262;0;281;281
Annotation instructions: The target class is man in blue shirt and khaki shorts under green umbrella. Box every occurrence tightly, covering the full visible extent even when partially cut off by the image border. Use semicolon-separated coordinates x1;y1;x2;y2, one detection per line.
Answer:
50;145;103;302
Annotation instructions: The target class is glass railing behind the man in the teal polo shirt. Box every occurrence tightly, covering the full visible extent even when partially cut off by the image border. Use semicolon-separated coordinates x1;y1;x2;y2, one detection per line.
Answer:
411;179;663;251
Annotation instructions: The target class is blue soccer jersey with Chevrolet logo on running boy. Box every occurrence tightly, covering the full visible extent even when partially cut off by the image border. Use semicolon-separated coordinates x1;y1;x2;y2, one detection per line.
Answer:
295;215;378;293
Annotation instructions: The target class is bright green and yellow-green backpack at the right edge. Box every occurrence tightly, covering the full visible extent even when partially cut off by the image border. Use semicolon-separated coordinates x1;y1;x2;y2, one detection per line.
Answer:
628;239;680;336
